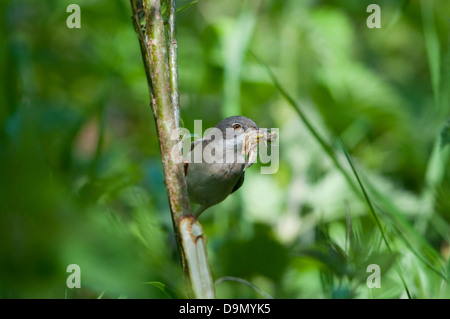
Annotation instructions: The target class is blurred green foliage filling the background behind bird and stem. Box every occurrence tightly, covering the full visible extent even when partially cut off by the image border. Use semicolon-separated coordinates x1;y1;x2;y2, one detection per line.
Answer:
0;0;450;298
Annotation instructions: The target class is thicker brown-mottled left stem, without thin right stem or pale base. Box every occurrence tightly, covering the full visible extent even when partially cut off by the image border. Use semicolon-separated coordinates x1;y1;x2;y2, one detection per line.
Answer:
131;0;191;294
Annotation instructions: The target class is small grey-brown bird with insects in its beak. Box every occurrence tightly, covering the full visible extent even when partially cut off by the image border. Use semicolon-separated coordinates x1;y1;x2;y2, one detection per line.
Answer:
184;116;271;218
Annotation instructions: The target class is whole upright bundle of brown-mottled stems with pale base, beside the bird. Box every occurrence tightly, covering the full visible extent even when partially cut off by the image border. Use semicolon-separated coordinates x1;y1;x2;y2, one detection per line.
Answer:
131;0;214;298
